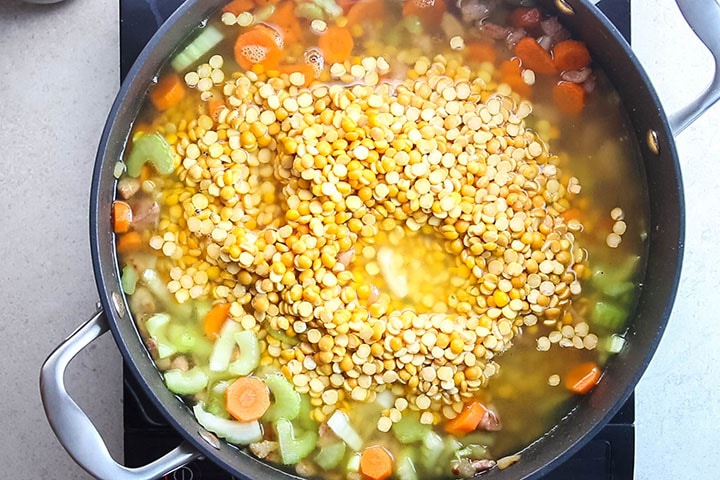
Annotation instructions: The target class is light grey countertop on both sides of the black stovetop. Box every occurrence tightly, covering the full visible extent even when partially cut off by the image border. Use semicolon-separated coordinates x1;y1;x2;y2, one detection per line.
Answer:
0;0;720;480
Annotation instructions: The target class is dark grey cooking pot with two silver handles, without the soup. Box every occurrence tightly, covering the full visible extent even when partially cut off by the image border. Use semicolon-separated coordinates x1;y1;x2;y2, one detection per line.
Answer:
40;0;720;480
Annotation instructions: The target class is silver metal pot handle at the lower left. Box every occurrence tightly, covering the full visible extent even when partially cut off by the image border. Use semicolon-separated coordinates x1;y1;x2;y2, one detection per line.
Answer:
40;310;200;480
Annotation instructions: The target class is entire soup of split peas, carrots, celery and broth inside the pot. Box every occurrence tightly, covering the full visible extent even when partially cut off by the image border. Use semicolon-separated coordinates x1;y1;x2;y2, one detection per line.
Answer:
113;0;647;480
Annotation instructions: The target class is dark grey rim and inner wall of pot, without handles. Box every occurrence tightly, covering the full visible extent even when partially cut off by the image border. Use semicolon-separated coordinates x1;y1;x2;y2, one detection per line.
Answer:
90;0;685;479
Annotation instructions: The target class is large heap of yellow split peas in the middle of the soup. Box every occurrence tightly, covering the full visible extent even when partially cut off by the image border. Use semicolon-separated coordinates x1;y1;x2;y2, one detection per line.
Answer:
153;52;593;430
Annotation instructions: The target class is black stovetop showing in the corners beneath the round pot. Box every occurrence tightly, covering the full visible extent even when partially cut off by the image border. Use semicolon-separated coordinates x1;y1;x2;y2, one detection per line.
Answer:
120;0;635;480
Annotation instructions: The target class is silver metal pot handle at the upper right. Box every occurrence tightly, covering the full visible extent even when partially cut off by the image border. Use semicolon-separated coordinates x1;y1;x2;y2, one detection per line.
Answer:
669;0;720;135
